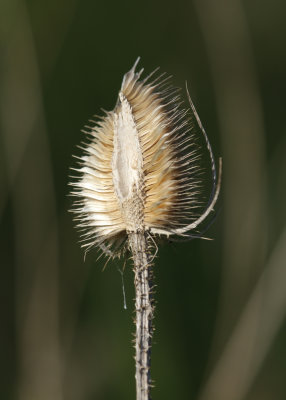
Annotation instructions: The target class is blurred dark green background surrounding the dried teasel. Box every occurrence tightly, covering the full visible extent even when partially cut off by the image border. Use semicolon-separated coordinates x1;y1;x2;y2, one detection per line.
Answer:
0;0;286;400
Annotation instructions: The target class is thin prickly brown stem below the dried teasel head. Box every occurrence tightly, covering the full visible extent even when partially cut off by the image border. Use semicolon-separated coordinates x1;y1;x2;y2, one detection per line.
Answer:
128;232;154;400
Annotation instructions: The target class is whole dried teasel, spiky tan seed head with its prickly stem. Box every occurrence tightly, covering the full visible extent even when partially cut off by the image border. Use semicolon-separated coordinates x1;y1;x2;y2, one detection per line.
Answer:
68;58;222;400
